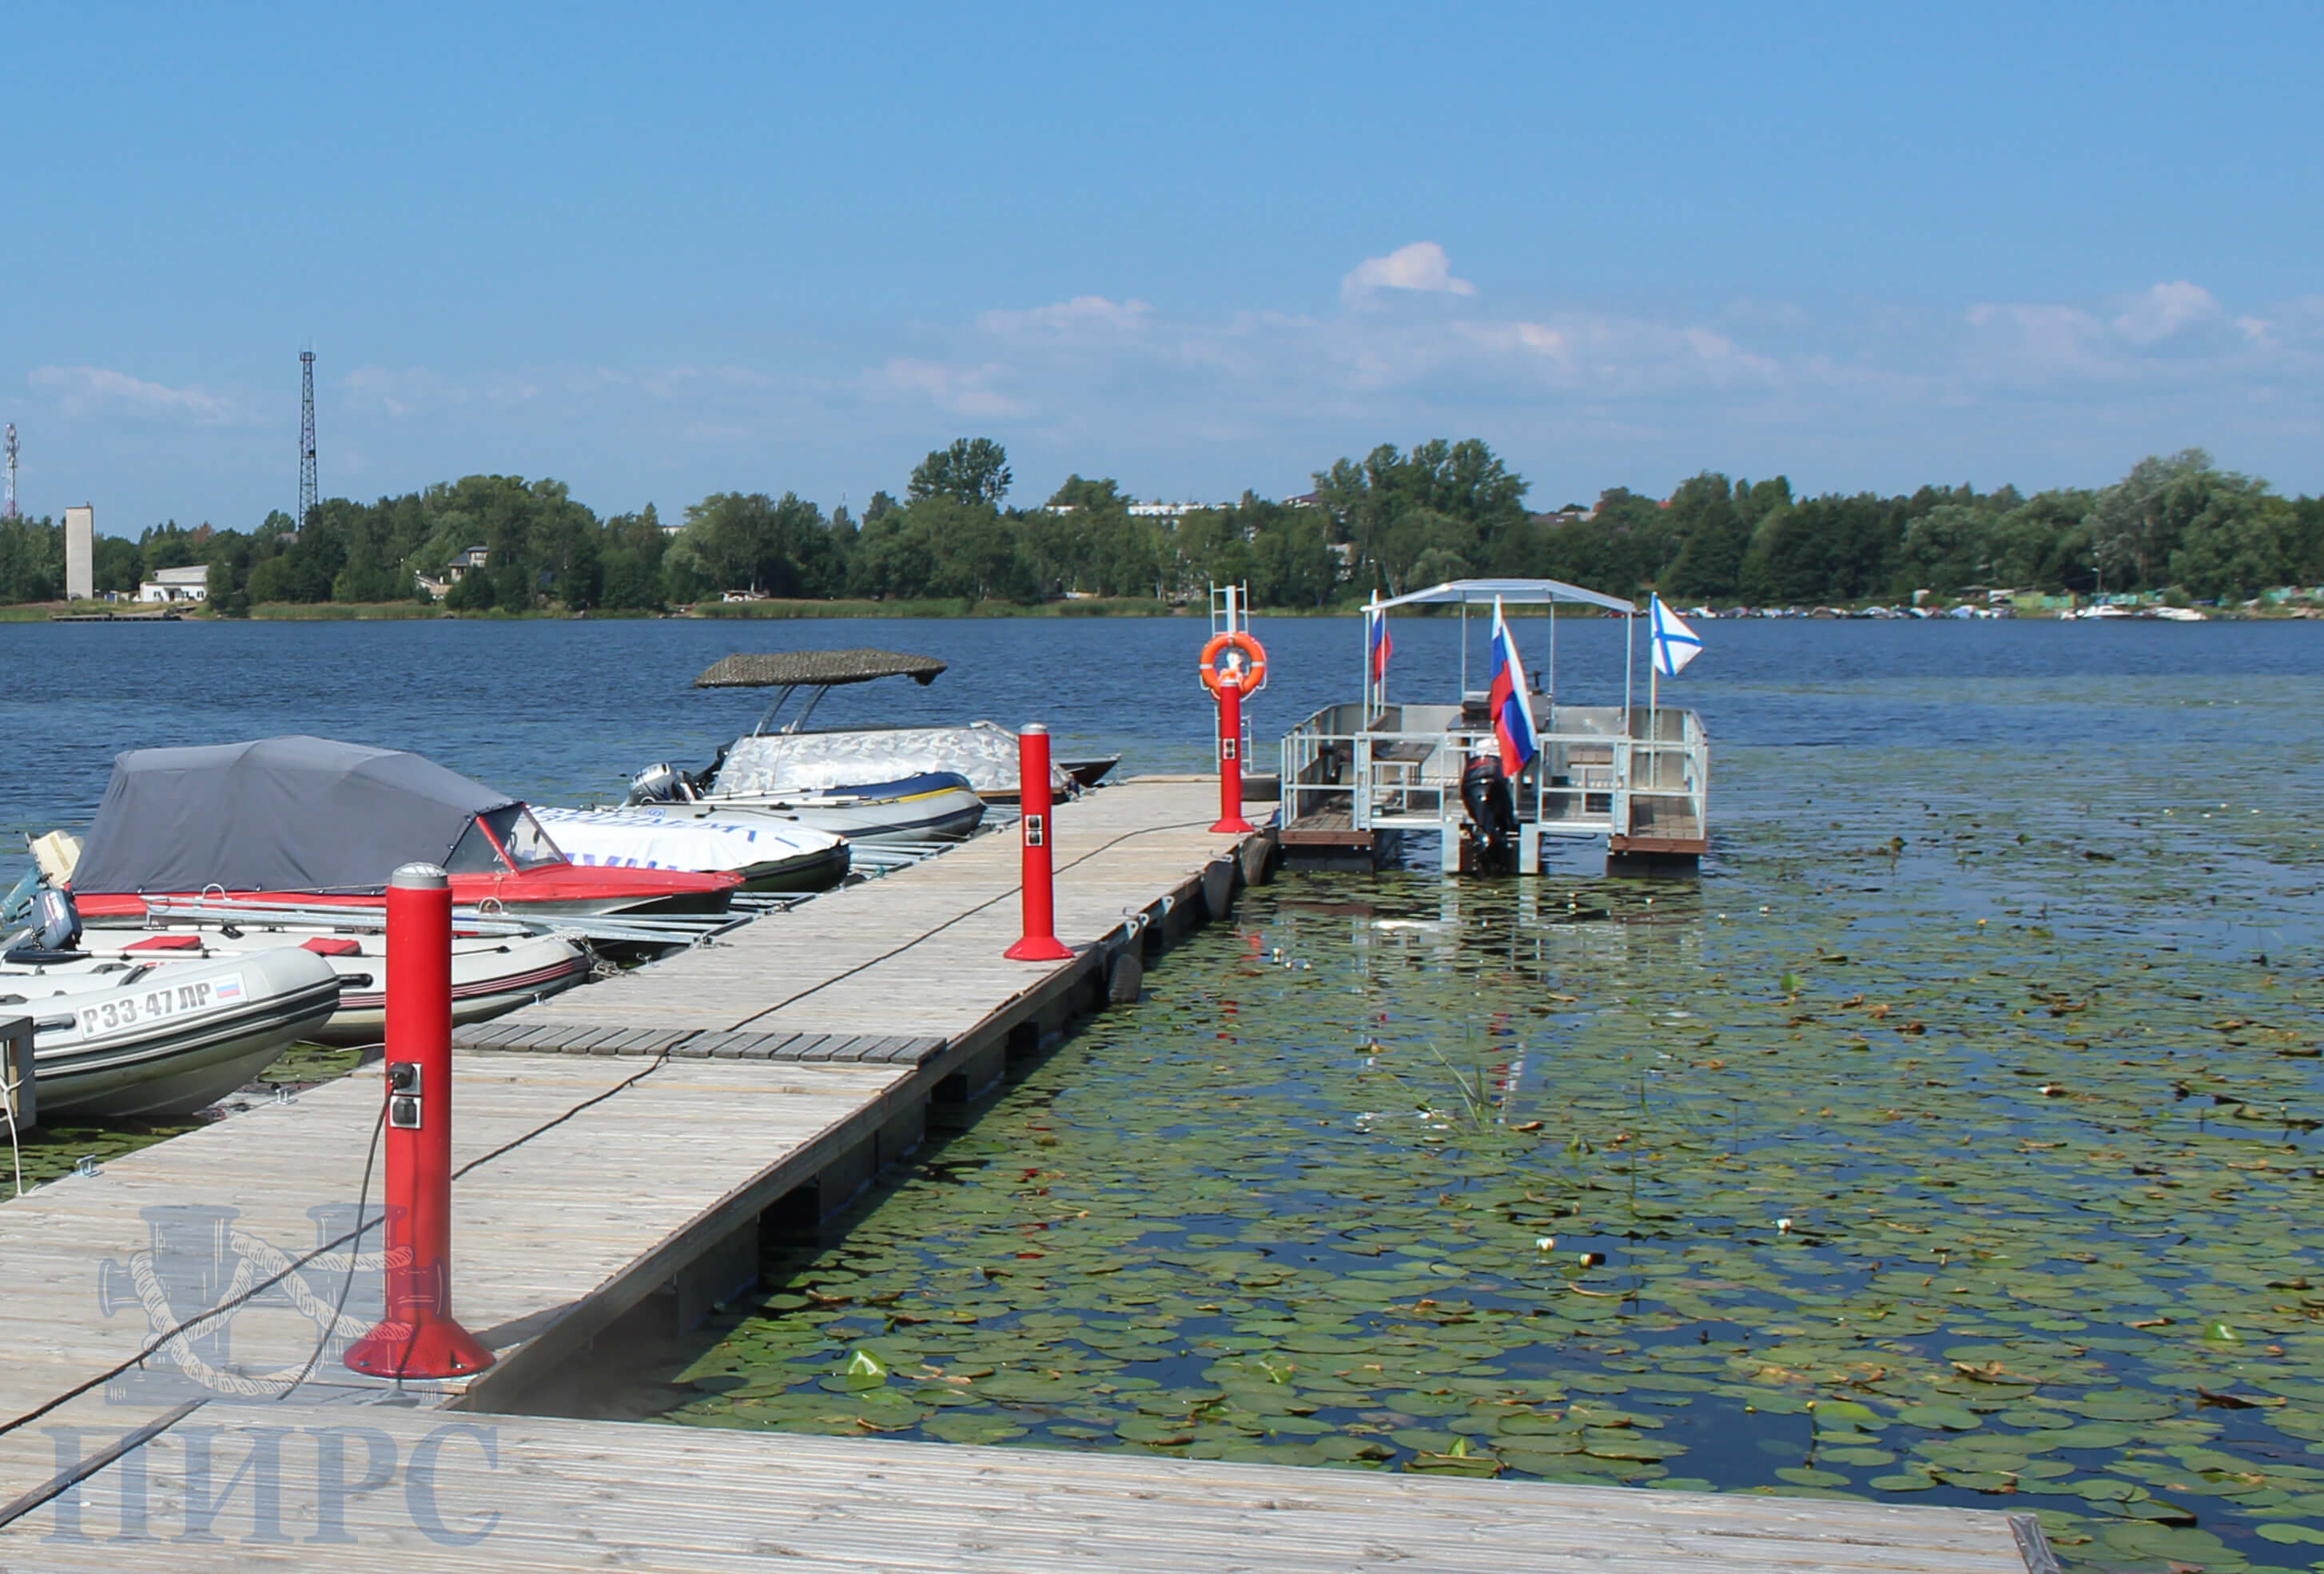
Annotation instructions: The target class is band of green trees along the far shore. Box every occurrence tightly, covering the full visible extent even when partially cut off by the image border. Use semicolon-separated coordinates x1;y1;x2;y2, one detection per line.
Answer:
18;437;2324;616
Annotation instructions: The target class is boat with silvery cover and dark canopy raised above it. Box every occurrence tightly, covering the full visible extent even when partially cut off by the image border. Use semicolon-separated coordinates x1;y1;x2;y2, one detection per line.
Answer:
646;649;1120;804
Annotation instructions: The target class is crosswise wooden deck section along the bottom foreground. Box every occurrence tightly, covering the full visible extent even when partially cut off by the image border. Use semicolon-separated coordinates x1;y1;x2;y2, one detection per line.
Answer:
0;1405;2024;1574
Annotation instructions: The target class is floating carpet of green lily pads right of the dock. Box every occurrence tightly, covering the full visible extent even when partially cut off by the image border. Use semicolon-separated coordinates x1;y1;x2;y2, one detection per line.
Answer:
567;837;2324;1569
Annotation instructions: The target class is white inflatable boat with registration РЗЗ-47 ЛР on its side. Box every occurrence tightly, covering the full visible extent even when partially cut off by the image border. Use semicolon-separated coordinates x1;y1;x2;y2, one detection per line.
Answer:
0;946;340;1123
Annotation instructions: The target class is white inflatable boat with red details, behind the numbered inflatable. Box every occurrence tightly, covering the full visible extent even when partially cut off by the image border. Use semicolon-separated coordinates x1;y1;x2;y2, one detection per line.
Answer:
29;920;597;1044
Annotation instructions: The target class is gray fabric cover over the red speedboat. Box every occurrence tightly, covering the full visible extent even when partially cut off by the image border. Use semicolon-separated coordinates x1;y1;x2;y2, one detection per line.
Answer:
72;737;516;892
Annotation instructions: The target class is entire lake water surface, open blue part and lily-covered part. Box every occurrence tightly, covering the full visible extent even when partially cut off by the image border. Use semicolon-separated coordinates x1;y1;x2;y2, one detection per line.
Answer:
14;621;2324;1569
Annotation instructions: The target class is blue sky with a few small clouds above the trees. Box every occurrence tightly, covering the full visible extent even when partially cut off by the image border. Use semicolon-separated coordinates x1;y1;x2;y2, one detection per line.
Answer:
0;2;2324;532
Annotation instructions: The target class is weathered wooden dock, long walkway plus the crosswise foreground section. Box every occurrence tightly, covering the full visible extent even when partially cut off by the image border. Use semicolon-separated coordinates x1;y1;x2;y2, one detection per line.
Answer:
0;781;2047;1574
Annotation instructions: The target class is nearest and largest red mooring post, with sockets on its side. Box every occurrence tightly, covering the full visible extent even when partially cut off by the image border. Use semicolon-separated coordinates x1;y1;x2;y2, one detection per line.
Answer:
344;863;492;1377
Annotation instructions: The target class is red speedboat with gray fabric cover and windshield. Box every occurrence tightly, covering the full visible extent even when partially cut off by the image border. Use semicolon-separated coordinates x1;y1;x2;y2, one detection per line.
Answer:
70;737;742;925
